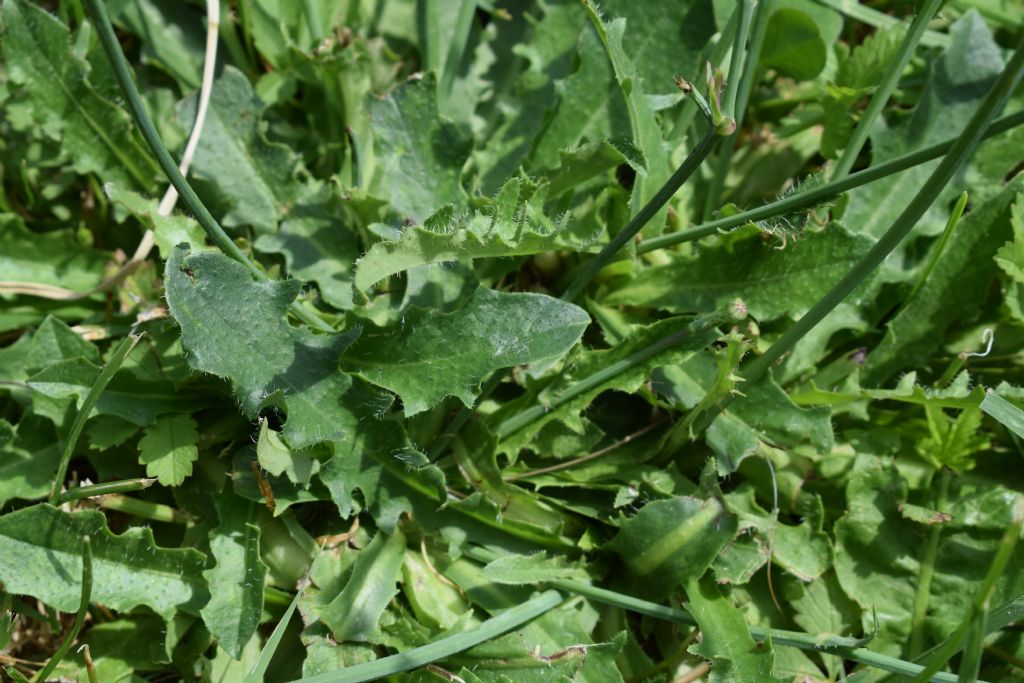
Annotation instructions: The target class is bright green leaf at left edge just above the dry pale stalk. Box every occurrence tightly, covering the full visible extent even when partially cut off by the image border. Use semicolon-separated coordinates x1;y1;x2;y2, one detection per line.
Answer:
0;215;110;292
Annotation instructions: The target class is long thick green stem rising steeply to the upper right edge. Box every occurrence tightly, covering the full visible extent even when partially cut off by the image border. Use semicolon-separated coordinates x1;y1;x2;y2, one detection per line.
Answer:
743;39;1024;382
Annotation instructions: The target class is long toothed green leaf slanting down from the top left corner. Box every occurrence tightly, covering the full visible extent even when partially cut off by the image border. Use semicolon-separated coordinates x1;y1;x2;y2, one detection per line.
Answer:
3;0;158;189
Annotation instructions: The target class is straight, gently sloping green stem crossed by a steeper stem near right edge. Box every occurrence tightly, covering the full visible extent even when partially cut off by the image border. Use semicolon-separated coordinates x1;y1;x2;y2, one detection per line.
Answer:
637;110;1024;254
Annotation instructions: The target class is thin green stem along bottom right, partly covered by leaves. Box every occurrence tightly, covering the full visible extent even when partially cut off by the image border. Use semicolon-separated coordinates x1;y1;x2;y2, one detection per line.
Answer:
466;546;956;683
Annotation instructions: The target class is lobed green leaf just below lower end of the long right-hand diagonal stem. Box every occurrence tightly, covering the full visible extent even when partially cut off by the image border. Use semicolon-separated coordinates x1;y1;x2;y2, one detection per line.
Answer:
707;379;833;475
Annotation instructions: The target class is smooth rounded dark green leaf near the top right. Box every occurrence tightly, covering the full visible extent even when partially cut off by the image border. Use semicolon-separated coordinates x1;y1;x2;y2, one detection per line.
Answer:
760;8;827;81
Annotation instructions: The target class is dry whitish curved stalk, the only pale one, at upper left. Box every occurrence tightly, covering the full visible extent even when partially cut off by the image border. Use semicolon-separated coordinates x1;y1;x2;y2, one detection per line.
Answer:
0;0;220;301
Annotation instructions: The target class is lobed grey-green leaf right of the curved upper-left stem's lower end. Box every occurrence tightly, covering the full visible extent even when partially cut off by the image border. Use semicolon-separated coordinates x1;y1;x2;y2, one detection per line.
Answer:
256;191;360;310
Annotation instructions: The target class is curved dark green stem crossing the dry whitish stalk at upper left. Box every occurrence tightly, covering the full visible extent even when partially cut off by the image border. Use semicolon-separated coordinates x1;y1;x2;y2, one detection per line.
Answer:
85;0;334;332
